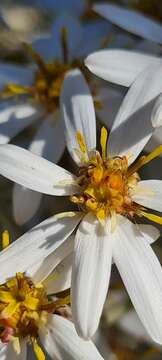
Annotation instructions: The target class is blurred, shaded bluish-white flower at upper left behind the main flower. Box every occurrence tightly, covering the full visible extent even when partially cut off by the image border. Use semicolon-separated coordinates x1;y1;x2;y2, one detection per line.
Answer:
0;9;111;224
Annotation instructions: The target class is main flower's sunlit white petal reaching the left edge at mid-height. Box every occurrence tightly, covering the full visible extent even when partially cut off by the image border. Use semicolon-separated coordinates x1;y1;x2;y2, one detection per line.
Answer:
0;144;77;195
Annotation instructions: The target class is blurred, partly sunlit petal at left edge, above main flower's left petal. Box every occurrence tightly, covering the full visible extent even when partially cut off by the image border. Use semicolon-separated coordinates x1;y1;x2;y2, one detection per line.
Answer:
0;100;40;144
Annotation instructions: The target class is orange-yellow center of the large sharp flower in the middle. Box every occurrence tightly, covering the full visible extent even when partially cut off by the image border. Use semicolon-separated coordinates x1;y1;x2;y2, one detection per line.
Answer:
71;128;139;222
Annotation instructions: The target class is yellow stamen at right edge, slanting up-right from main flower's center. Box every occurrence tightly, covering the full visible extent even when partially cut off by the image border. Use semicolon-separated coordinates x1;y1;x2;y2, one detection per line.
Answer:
128;145;162;176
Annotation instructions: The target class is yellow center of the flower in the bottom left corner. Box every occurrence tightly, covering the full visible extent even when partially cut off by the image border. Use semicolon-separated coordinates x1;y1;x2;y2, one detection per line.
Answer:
0;273;67;360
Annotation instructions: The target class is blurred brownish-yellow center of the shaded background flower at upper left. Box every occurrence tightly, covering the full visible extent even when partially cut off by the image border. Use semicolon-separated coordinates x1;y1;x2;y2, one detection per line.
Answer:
1;27;84;113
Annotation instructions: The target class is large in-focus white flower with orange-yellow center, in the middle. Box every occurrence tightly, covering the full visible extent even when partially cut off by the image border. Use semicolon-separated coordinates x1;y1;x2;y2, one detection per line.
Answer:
0;62;162;343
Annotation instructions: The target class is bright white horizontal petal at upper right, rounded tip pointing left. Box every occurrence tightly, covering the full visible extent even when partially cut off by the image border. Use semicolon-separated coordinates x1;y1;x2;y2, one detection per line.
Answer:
85;49;159;86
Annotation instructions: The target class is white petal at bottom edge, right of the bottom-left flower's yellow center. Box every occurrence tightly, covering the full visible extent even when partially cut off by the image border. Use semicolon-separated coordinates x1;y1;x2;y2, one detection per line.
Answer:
39;315;103;360
